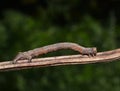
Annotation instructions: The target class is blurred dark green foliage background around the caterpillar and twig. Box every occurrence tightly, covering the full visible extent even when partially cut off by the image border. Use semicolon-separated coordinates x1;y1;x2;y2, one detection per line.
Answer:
0;0;120;91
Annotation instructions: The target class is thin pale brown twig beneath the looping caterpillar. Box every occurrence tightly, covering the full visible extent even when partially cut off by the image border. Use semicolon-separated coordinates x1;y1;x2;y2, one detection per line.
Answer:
0;49;120;71
